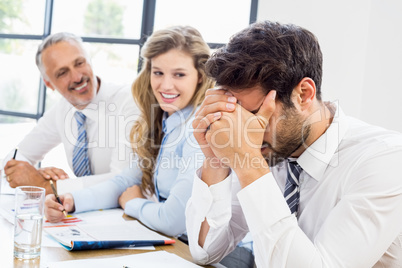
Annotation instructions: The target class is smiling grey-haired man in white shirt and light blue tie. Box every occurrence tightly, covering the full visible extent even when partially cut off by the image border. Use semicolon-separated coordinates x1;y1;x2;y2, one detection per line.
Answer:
4;32;139;193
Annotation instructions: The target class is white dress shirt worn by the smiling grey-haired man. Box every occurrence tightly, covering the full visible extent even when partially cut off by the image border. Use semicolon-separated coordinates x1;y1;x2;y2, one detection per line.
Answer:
3;78;139;194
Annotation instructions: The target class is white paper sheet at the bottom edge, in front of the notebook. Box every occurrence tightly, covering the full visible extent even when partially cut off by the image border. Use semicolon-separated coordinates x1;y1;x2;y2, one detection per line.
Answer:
44;251;201;268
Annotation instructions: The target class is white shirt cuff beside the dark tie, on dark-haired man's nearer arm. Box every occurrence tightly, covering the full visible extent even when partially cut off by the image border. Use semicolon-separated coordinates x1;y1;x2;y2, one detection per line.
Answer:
237;172;291;233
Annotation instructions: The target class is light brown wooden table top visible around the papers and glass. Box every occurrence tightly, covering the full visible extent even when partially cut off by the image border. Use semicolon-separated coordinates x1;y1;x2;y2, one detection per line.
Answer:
0;195;214;268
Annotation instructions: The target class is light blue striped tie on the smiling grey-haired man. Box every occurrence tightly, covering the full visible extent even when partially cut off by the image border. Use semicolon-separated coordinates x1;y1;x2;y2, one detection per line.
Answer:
73;111;91;177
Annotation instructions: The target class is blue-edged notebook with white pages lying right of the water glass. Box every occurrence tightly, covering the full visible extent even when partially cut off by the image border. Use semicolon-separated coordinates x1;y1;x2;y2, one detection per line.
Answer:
43;220;175;250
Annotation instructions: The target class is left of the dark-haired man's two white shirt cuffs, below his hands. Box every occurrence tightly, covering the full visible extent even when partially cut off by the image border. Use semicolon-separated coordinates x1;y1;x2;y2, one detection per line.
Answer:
192;168;233;228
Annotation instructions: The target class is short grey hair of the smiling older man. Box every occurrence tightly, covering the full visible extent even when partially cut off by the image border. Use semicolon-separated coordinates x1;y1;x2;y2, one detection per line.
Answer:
36;32;83;76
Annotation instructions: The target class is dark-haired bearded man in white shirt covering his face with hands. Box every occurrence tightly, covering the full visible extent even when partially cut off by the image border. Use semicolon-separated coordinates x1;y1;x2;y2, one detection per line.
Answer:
186;21;402;268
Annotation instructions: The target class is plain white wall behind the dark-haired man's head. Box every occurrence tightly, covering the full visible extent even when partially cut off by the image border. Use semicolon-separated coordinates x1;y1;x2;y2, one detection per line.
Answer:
258;0;402;132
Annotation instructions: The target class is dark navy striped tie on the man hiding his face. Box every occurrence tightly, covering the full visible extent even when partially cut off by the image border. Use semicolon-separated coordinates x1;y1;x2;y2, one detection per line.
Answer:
283;159;303;216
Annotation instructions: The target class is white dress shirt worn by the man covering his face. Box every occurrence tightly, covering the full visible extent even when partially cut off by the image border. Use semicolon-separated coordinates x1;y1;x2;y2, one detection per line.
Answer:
186;103;402;268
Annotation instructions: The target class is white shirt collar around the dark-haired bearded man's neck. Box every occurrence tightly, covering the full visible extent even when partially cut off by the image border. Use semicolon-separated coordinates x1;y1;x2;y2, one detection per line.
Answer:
297;102;349;181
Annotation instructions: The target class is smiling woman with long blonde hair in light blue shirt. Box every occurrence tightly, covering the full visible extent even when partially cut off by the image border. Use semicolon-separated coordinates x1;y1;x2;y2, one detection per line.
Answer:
45;26;214;236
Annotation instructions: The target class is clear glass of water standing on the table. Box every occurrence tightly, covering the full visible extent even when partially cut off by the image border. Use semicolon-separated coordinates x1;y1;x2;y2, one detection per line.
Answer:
14;186;46;259
